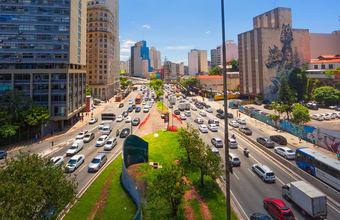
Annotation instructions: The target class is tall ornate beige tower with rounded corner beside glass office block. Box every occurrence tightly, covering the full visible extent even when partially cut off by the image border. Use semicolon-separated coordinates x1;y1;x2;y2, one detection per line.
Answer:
86;0;120;100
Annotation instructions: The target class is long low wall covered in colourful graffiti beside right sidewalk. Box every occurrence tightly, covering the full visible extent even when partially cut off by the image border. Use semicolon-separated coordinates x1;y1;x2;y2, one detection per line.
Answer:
238;106;340;153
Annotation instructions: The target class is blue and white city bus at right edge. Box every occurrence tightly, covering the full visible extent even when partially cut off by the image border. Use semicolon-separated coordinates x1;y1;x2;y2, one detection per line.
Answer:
295;147;340;190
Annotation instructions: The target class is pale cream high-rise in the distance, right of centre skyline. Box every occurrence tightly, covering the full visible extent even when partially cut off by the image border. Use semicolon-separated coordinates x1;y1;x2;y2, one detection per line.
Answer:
188;49;208;76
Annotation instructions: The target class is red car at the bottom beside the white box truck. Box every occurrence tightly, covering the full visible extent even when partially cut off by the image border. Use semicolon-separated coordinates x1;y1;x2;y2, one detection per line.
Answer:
263;198;295;220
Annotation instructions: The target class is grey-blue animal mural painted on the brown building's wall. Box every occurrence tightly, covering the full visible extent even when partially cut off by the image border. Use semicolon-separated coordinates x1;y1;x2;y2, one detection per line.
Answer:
265;24;300;94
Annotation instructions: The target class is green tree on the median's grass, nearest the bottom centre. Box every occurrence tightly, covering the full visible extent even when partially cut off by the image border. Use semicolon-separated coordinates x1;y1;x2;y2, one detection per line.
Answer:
146;164;186;216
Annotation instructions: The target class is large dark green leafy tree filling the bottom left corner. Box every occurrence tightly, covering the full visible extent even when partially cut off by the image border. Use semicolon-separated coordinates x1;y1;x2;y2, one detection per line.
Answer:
0;152;77;219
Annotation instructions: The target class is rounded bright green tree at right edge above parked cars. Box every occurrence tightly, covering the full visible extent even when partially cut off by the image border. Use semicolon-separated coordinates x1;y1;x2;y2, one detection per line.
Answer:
313;86;340;105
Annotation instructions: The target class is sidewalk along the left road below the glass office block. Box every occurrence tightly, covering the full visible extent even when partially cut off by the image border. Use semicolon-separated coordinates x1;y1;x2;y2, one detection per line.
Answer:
1;106;106;153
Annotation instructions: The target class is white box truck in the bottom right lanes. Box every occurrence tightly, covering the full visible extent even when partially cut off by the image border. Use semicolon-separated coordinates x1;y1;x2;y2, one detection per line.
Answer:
282;181;327;219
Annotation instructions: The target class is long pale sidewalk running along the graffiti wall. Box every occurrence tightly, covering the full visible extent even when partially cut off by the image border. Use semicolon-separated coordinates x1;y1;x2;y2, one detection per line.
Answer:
193;96;338;159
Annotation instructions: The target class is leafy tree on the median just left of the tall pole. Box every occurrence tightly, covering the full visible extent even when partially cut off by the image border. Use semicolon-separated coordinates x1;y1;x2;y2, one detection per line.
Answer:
191;139;224;187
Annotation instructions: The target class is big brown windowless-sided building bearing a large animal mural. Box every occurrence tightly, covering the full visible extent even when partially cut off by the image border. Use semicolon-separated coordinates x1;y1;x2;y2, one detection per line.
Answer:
238;8;310;100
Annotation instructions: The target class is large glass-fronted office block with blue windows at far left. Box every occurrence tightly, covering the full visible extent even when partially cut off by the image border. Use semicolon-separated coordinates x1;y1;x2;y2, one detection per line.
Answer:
0;0;87;131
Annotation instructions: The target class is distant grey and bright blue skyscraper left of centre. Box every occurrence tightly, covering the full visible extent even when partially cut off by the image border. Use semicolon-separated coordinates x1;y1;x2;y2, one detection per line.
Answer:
130;41;152;77
